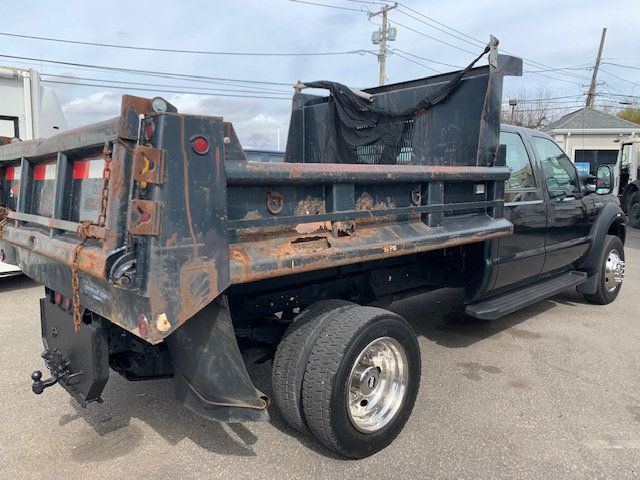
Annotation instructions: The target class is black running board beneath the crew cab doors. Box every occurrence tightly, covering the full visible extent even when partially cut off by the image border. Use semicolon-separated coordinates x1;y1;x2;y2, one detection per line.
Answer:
466;272;587;320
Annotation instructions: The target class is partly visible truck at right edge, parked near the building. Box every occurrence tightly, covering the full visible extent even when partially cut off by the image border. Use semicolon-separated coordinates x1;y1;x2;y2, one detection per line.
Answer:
614;135;640;228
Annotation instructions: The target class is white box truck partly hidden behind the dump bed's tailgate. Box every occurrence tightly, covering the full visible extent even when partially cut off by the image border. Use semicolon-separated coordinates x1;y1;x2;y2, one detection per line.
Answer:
0;66;67;277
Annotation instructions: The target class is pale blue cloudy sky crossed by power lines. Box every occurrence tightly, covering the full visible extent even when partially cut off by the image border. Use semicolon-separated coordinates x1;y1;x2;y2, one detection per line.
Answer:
0;0;640;149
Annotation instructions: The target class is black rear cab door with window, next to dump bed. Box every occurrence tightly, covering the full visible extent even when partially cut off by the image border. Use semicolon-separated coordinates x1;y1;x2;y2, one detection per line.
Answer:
493;126;547;290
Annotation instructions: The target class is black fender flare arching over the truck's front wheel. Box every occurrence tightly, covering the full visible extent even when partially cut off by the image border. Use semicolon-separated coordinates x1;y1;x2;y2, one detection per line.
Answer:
578;203;626;293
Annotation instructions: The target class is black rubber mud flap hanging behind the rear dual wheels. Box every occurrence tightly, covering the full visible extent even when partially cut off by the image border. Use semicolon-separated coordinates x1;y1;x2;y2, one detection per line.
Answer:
166;297;269;423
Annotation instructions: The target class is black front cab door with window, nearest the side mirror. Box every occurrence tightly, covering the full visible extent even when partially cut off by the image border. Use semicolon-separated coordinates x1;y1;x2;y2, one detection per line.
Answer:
532;135;596;273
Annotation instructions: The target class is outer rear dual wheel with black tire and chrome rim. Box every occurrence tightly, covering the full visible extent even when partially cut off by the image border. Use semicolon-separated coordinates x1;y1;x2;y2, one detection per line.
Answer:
302;307;420;458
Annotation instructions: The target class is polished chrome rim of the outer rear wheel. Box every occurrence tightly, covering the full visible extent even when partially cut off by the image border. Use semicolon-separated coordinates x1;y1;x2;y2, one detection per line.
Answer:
347;337;409;433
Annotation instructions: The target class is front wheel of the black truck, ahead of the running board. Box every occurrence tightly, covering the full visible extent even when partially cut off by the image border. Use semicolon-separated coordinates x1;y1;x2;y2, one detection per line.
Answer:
584;235;624;305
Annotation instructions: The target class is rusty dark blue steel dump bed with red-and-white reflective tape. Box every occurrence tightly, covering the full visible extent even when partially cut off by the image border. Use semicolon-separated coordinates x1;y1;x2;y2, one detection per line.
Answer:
0;52;521;343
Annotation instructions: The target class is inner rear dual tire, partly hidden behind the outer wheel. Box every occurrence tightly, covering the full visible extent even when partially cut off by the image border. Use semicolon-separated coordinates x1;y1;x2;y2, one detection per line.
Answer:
271;300;356;433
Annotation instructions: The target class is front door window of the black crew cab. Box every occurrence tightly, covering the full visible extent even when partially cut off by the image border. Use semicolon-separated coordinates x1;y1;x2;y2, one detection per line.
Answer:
533;137;580;197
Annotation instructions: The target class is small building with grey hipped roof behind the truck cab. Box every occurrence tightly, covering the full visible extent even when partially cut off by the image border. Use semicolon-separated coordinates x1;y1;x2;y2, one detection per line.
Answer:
543;107;640;173
